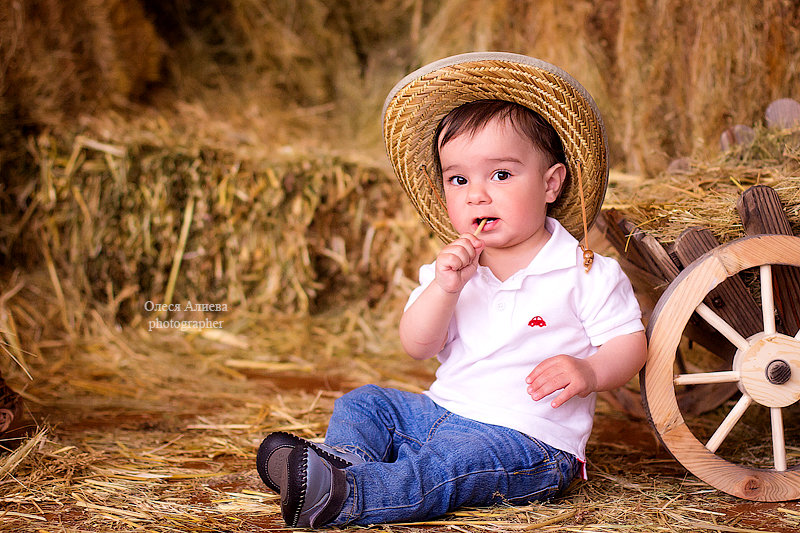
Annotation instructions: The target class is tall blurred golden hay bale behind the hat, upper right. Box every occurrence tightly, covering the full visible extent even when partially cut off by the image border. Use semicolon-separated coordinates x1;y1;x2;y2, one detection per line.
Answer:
410;0;800;176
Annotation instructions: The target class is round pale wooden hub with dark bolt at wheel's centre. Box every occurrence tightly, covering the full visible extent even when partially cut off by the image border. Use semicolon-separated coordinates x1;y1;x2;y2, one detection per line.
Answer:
733;333;800;407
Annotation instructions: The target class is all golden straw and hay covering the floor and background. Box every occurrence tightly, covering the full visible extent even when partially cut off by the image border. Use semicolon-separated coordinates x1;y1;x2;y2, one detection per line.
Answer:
0;4;800;533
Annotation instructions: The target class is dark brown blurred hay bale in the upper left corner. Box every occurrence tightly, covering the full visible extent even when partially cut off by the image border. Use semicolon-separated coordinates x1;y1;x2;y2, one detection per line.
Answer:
0;0;165;128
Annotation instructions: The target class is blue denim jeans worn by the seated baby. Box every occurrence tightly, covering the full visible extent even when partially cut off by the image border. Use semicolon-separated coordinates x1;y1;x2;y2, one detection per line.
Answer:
325;385;580;525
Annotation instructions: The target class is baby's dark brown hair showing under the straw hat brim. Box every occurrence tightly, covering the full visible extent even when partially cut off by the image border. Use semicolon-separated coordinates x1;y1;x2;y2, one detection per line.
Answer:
433;100;569;174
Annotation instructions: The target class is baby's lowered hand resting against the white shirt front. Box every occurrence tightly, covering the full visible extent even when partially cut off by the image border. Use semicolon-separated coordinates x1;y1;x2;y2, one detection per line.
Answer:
525;354;597;408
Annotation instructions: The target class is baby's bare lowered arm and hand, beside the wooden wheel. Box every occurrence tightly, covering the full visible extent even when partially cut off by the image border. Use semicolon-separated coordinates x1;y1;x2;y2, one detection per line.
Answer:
525;331;647;407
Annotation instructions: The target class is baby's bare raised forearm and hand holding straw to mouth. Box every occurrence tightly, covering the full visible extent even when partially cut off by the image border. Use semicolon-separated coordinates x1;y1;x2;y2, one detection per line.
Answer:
400;234;483;359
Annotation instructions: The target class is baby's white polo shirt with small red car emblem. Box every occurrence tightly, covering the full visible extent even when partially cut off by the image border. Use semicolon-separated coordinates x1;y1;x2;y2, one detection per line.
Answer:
406;217;644;461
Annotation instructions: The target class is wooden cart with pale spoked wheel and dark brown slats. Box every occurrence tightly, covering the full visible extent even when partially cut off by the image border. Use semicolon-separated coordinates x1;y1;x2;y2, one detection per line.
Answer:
599;186;800;501
